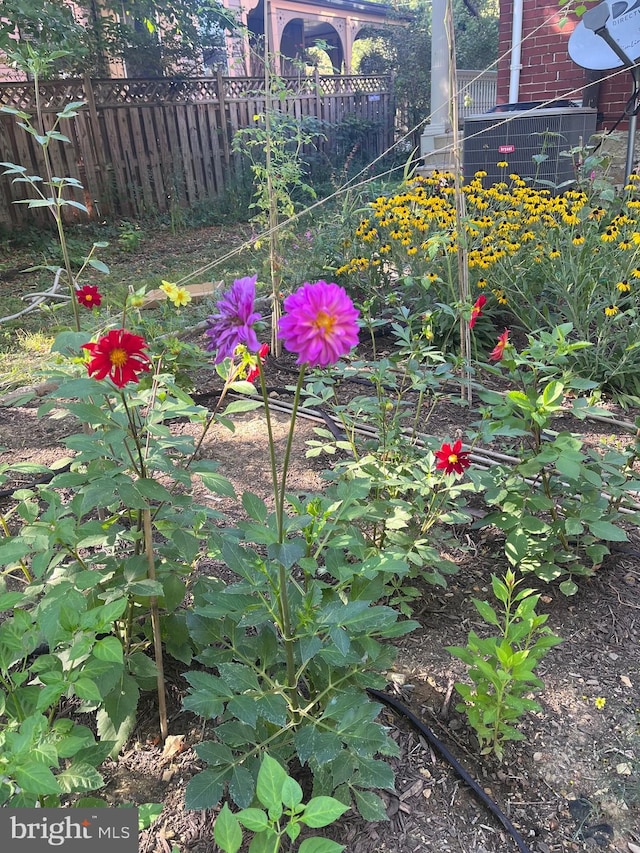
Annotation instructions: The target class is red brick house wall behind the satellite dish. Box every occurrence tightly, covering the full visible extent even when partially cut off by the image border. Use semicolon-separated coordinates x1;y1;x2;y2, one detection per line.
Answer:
497;0;631;127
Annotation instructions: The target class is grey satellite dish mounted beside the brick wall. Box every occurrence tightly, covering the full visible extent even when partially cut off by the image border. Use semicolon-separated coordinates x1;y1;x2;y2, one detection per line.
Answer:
569;0;640;71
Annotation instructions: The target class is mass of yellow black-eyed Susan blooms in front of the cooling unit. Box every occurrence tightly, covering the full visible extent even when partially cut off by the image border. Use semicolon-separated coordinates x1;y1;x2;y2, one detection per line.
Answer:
336;163;640;316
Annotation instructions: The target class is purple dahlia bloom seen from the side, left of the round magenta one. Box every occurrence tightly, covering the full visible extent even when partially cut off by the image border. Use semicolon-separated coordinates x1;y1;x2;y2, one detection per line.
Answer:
205;275;261;364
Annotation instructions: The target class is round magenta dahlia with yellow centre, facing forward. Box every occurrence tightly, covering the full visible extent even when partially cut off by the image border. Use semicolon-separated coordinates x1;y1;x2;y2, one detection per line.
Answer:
278;281;358;367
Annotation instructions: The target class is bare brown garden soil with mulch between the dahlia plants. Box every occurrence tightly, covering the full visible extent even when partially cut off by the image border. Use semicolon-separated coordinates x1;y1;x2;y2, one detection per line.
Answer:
0;334;640;853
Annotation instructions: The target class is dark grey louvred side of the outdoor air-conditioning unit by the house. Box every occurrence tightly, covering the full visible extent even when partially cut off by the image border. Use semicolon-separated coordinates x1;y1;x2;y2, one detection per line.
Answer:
463;107;597;186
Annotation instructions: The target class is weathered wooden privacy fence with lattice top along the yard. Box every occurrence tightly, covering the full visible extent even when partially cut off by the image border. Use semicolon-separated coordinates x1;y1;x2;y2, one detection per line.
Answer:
0;75;394;227
